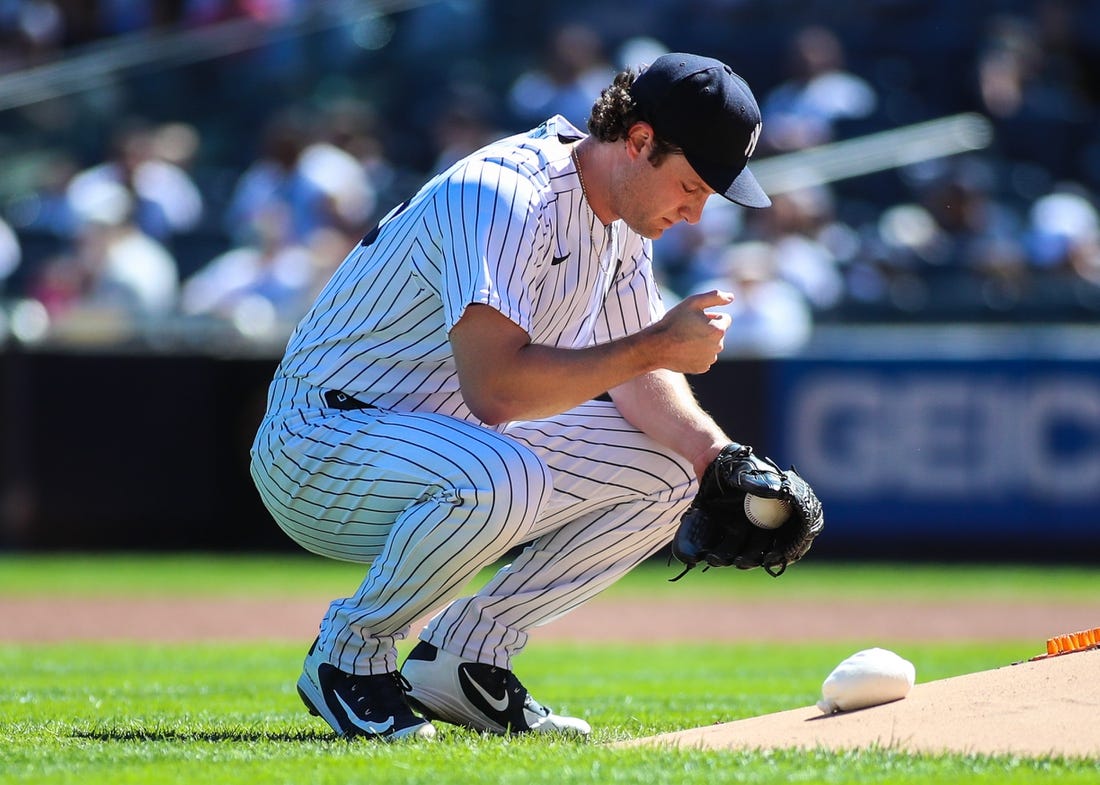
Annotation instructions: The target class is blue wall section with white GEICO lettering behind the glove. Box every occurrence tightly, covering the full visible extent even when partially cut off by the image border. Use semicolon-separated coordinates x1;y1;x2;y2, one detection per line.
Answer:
769;351;1100;560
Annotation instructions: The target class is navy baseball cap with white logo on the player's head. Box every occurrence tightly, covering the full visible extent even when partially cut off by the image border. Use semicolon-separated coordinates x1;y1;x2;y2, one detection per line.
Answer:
630;53;771;207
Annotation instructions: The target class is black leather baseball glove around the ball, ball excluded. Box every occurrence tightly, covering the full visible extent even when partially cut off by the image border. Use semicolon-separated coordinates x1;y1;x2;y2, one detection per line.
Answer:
672;443;825;581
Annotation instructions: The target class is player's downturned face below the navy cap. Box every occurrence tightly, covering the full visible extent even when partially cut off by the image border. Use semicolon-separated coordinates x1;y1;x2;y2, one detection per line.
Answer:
612;133;714;240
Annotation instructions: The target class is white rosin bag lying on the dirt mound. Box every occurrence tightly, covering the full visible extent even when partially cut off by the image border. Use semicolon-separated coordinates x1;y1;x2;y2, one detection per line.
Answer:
817;649;916;715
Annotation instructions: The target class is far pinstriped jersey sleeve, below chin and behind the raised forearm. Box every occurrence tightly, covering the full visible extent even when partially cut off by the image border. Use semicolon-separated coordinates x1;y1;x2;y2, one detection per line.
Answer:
594;232;664;344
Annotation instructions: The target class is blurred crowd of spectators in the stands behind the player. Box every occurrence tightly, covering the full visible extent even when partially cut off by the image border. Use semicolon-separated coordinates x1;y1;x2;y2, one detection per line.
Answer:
0;0;1100;355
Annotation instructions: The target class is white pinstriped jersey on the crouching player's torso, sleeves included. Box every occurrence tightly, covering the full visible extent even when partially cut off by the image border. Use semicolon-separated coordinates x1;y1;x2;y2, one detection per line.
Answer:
272;115;663;421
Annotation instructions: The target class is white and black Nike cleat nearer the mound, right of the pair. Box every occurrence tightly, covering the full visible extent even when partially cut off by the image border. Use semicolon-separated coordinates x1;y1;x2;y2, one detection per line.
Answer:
402;641;592;736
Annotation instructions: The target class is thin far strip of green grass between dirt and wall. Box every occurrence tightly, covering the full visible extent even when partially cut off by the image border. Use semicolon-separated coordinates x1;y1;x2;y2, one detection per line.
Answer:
0;554;1100;602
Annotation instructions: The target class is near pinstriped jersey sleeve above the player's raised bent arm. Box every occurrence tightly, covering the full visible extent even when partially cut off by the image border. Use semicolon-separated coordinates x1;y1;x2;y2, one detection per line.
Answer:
435;161;548;332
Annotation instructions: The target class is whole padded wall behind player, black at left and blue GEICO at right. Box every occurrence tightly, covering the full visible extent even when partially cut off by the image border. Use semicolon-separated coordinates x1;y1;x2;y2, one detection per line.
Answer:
0;329;1100;561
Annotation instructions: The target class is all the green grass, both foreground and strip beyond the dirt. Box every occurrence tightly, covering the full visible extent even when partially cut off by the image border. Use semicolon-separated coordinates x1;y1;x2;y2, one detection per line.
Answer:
0;556;1100;785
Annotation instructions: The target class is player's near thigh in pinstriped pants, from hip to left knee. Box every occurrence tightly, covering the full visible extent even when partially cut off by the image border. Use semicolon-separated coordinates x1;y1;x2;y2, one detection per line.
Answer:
253;409;550;561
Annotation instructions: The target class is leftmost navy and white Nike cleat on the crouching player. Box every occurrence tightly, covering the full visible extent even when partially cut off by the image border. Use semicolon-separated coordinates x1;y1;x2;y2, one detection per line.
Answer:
298;641;436;741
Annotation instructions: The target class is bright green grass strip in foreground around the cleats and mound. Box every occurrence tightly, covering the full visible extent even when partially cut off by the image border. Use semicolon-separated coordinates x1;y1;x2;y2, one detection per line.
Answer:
0;644;1100;785
